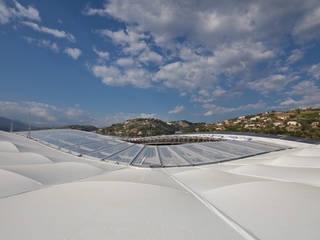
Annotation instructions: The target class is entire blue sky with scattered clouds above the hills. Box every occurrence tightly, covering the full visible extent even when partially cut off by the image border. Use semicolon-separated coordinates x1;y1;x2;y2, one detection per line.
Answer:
0;0;320;126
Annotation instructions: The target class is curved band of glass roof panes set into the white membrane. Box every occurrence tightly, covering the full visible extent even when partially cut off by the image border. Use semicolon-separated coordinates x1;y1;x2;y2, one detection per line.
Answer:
19;129;284;167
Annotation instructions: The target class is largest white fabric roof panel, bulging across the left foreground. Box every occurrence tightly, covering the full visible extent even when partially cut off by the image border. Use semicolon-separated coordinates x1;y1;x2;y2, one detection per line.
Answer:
0;182;243;240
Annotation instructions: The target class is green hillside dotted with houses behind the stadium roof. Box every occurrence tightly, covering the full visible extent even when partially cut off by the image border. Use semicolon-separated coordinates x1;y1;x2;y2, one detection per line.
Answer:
98;108;320;139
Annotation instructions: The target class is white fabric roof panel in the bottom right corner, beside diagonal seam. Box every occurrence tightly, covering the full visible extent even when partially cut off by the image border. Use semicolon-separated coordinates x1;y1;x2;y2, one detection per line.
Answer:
204;181;320;240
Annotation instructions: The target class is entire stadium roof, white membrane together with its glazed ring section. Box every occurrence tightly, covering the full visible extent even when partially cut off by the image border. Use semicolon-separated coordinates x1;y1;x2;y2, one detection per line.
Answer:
0;130;320;240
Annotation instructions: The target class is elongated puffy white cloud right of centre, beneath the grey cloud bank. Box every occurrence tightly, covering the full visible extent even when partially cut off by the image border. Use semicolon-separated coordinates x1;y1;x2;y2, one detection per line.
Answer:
155;42;274;90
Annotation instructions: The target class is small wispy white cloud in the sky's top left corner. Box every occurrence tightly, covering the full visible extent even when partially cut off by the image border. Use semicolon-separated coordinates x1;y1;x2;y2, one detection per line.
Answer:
0;0;41;24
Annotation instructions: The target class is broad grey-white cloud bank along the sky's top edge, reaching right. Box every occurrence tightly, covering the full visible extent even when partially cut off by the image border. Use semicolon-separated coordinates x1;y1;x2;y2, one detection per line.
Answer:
84;0;319;47
